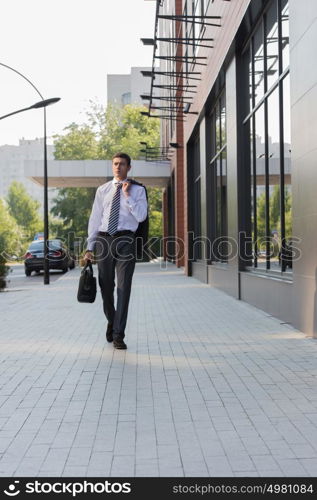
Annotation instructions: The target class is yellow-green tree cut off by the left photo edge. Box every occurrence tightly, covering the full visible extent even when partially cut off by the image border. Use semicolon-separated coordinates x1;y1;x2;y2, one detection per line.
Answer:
0;199;21;290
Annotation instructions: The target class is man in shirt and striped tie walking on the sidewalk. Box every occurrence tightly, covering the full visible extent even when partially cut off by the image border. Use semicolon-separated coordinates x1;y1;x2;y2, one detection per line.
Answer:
84;153;148;349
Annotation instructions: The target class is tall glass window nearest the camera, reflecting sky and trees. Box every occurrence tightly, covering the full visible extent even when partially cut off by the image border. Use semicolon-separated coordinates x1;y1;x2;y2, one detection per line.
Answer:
244;0;292;272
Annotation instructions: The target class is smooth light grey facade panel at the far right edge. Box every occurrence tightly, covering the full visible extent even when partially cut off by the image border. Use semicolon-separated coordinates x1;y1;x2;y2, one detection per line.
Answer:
290;0;317;336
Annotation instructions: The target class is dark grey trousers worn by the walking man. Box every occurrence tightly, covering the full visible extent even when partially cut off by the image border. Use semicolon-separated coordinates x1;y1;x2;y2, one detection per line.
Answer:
95;234;135;339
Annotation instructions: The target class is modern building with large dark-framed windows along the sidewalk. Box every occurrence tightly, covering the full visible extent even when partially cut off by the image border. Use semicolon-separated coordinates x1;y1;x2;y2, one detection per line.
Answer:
146;0;317;335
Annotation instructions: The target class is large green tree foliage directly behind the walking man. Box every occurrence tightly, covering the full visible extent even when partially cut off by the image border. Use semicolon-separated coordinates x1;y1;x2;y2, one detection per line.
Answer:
51;102;162;247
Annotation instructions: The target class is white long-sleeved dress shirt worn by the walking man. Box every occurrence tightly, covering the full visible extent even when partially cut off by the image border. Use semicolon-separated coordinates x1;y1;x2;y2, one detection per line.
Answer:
87;178;147;250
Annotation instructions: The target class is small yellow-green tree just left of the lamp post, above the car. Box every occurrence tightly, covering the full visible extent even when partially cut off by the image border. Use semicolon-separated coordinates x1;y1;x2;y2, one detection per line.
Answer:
7;181;43;241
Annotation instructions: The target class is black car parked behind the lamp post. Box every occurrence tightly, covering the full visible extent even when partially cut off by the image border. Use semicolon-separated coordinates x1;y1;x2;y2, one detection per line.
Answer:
24;240;75;276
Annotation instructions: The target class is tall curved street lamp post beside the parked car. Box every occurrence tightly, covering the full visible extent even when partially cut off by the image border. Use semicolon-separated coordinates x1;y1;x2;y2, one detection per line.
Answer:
0;62;60;285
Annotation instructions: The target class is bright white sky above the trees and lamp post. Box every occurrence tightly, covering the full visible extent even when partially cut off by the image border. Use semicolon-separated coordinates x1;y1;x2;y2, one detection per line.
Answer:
0;0;156;146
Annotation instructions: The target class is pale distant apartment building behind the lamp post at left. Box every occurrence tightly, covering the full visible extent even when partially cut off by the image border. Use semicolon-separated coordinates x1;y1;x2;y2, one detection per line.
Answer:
0;139;57;213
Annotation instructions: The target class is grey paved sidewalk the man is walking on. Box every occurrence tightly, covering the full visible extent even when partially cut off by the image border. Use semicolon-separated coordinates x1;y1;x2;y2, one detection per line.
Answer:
0;263;317;477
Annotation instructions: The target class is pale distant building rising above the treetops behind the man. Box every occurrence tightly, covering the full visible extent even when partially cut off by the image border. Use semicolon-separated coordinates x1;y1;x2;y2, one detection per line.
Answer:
107;67;151;106
